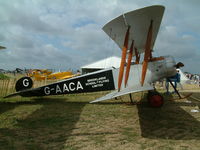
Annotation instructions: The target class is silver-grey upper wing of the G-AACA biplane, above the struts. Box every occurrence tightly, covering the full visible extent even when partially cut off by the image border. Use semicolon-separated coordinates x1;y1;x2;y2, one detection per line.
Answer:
103;5;165;55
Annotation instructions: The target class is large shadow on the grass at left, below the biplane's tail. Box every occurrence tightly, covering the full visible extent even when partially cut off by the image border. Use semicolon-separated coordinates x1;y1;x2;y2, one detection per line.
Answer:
0;98;117;149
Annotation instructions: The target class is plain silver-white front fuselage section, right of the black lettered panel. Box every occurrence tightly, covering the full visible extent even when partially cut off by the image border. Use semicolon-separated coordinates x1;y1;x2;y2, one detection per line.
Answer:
113;56;176;89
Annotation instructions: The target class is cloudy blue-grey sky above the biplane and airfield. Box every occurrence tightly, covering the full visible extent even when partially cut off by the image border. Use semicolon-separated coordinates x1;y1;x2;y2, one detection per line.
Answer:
0;0;200;73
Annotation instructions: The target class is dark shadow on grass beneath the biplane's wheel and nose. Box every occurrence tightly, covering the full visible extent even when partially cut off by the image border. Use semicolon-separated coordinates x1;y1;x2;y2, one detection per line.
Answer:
137;92;200;140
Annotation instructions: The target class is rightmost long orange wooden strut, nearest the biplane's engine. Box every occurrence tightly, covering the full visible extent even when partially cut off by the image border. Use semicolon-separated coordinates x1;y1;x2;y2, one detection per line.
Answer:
141;20;153;86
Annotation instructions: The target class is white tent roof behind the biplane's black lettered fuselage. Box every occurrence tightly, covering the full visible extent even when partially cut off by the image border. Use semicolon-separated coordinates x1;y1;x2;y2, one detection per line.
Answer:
81;56;121;74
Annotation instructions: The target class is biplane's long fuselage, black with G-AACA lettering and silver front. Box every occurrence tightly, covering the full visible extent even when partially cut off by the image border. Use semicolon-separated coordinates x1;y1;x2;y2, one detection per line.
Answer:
4;56;176;97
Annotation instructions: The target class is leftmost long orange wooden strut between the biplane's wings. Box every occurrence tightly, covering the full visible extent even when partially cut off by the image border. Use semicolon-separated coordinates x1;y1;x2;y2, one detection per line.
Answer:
118;26;130;92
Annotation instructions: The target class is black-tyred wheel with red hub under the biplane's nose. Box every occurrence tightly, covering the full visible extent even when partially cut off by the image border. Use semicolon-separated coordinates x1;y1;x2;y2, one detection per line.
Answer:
147;91;164;108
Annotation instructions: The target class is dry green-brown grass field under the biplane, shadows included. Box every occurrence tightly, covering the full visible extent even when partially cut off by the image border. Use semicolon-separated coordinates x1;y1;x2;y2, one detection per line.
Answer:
0;86;200;150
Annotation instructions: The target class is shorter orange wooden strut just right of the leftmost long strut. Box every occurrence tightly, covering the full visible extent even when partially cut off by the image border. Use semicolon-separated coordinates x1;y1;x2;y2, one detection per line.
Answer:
124;41;134;87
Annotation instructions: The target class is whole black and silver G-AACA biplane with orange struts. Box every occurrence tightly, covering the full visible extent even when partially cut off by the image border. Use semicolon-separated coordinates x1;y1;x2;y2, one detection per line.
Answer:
3;5;188;107
